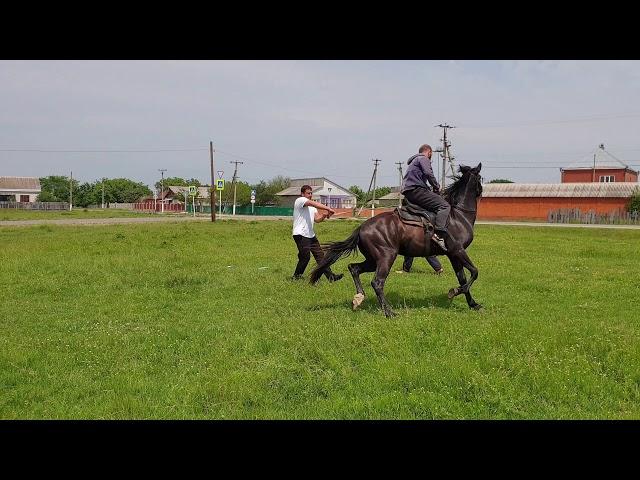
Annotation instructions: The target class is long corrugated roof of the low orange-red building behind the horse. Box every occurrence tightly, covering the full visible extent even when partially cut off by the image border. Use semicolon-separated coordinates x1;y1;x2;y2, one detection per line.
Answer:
482;182;640;198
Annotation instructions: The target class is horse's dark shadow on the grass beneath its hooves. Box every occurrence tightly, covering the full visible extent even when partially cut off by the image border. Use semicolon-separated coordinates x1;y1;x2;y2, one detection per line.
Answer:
311;292;468;314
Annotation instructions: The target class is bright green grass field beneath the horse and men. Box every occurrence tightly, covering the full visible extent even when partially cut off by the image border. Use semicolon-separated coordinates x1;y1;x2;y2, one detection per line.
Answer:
0;221;640;419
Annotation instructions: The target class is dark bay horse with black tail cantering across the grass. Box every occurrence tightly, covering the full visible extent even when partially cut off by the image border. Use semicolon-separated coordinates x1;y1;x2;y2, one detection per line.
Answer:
310;163;482;317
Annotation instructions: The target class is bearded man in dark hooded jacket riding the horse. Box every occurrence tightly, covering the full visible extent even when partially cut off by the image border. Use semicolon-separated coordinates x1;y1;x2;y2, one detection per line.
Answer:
401;144;451;252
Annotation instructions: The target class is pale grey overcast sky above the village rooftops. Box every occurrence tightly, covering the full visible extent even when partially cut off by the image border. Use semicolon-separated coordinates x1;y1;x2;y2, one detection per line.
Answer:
0;60;640;191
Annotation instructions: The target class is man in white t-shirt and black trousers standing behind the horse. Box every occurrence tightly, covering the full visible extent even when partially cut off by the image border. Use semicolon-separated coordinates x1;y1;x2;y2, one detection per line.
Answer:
293;185;342;282
